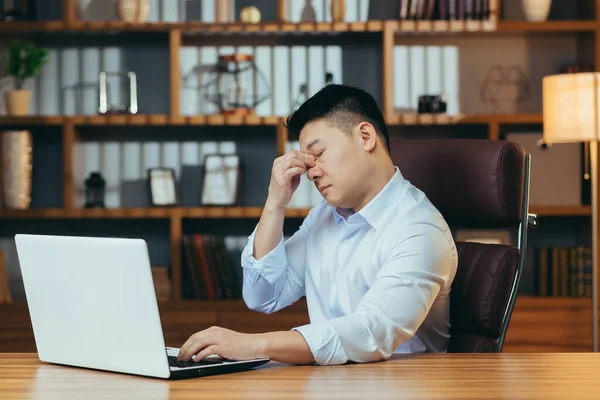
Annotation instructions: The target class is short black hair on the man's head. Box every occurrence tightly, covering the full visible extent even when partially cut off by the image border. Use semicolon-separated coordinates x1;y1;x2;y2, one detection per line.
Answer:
285;84;391;153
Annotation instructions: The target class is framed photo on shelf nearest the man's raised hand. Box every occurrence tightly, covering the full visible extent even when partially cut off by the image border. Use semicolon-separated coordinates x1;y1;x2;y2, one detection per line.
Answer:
201;154;241;206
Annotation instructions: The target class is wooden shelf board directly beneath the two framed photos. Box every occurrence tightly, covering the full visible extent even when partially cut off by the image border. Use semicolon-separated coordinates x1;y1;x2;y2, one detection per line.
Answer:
0;207;309;219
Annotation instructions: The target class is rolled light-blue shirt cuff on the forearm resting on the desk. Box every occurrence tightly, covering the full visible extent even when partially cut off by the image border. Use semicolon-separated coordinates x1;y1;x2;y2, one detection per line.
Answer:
292;322;348;365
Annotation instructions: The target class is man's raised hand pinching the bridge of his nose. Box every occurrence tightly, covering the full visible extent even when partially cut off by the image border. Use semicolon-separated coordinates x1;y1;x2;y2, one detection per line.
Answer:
267;150;316;207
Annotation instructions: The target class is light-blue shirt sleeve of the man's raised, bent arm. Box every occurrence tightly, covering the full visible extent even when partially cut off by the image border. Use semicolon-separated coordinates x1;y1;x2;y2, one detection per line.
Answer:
241;206;314;314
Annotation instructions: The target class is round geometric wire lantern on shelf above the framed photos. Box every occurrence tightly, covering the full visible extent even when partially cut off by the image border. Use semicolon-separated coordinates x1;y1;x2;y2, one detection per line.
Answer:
205;53;271;115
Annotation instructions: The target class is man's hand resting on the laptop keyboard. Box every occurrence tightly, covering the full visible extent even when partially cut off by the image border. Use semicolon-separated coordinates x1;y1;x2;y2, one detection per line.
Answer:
177;326;263;361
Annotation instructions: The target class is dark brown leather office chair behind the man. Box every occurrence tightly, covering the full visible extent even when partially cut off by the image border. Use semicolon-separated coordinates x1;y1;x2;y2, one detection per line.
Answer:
391;139;537;352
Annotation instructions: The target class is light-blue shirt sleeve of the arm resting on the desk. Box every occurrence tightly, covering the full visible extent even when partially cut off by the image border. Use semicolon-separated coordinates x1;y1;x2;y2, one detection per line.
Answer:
294;223;458;365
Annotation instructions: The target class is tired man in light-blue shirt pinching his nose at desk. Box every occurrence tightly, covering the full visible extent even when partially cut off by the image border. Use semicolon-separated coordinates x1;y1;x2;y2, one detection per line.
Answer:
179;85;458;365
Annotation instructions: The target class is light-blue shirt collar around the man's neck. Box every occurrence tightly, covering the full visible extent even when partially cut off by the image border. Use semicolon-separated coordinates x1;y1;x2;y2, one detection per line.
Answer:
333;166;405;229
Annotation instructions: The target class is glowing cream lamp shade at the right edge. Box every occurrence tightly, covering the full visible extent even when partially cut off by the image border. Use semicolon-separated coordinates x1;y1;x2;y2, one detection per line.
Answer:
542;72;600;143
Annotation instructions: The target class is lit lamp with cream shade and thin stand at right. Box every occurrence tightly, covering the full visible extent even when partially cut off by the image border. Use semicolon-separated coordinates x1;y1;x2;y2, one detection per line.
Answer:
534;72;600;352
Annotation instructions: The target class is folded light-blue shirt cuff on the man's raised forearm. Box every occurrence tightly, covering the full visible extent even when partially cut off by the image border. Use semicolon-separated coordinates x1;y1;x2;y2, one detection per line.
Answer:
242;225;287;285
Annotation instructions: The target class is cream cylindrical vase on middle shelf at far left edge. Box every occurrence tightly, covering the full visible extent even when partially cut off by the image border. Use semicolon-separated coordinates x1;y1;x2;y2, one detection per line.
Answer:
2;131;33;210
